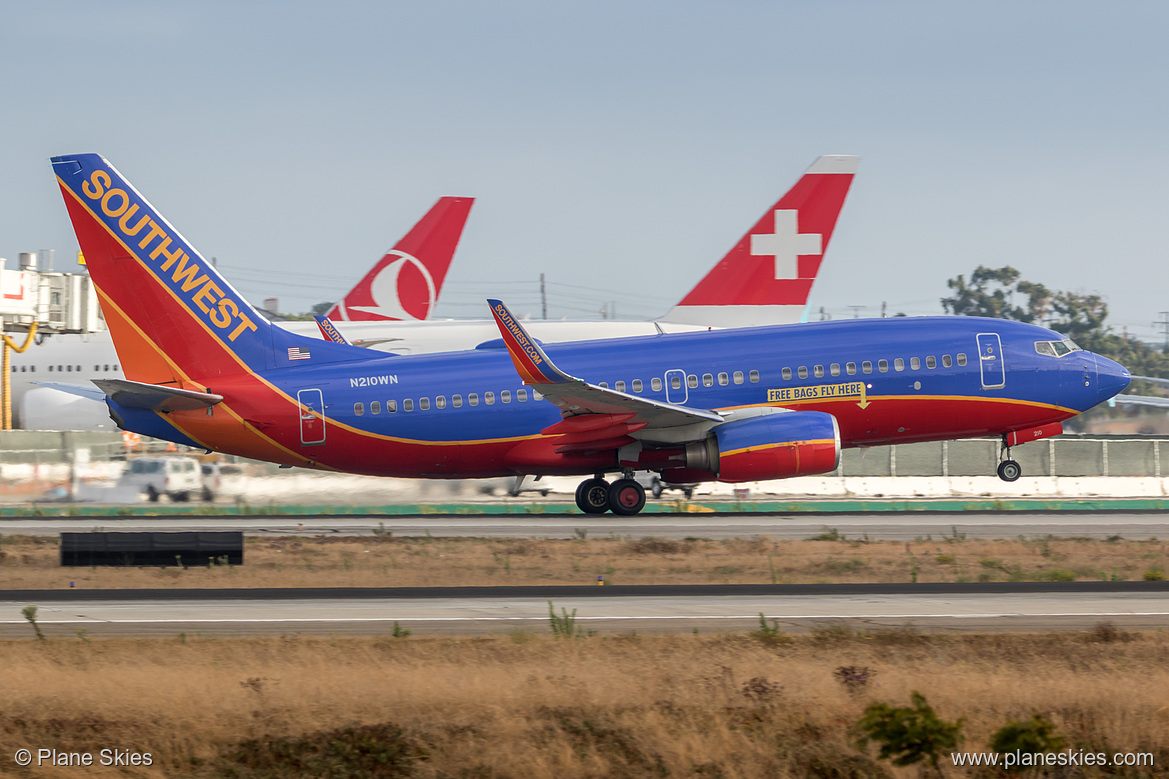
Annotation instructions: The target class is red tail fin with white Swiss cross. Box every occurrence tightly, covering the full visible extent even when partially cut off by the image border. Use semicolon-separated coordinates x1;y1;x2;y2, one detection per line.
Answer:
662;154;860;328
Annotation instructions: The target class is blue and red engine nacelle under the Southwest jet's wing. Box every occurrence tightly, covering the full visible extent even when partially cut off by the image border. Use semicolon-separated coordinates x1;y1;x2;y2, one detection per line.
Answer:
706;412;841;482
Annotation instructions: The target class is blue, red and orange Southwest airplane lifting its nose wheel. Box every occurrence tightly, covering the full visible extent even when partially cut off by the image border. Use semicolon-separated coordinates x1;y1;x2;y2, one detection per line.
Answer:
53;154;1129;515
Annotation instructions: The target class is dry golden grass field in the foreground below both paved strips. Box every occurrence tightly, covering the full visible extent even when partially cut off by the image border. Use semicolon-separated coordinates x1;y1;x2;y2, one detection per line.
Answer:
0;630;1169;779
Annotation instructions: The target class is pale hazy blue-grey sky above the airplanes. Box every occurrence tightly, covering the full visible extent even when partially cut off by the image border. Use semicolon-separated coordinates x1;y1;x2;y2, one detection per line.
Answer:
0;0;1169;338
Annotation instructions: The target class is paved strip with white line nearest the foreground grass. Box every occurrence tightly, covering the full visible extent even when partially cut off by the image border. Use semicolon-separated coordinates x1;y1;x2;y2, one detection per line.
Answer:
0;581;1169;637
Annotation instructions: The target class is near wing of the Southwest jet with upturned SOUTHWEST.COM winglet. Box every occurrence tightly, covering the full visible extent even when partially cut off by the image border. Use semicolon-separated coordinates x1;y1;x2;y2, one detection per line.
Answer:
487;299;726;448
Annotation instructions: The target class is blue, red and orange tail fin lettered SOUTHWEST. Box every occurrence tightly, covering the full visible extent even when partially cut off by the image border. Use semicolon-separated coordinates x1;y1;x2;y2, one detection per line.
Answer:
51;154;369;390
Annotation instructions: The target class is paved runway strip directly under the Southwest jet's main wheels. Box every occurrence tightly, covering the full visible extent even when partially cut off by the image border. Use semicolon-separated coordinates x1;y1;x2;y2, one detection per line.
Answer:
0;511;1169;540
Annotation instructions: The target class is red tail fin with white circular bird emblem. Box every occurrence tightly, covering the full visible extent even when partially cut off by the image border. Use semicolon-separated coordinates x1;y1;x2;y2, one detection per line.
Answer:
326;198;475;322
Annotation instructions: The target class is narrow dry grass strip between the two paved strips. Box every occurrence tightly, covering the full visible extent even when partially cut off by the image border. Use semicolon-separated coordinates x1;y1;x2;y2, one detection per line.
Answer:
0;532;1169;588
